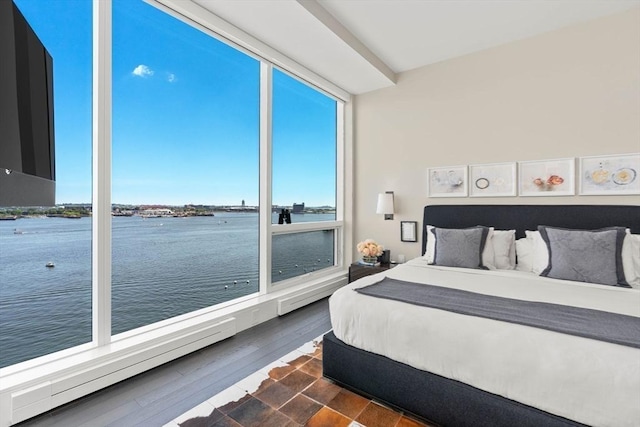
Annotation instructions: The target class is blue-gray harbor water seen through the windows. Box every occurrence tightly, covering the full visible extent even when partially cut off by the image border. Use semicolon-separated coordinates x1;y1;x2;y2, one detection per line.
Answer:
0;213;334;367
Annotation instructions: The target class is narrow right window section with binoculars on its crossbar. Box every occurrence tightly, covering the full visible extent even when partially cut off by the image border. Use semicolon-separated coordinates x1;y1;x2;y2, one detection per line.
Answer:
271;70;339;283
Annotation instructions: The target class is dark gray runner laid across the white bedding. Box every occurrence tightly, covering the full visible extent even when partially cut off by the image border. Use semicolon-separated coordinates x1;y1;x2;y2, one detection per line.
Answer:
355;277;640;348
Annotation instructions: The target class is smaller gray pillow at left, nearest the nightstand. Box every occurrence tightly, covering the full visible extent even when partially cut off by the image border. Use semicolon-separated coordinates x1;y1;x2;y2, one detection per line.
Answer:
432;226;489;269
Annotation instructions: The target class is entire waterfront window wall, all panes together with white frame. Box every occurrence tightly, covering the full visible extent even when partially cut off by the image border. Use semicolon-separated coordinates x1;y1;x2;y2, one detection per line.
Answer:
0;4;345;424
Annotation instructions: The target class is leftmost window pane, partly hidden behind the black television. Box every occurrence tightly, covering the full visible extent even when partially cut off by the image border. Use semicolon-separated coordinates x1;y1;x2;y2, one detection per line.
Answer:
0;0;92;367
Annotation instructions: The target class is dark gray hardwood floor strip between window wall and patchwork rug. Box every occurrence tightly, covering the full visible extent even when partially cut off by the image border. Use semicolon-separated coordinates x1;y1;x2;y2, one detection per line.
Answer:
18;299;331;427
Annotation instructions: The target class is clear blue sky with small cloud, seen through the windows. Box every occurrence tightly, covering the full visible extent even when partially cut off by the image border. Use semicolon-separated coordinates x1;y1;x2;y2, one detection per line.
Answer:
15;0;336;206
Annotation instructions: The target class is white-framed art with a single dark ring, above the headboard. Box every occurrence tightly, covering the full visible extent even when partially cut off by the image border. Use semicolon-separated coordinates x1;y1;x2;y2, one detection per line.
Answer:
469;162;518;197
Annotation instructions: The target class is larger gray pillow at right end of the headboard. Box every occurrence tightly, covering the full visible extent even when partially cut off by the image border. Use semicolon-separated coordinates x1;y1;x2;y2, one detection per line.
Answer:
538;225;630;288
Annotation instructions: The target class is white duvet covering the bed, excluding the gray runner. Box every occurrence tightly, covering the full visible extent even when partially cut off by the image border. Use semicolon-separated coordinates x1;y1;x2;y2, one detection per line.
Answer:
329;258;640;426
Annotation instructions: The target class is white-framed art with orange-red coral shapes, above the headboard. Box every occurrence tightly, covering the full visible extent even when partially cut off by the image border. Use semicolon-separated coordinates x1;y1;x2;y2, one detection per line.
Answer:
518;157;576;197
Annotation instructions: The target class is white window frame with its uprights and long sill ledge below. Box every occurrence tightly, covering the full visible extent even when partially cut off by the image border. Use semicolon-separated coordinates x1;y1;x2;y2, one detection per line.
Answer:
0;0;353;425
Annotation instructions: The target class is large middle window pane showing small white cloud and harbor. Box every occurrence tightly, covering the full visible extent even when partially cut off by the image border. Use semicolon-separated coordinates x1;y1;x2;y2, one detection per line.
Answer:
112;0;260;334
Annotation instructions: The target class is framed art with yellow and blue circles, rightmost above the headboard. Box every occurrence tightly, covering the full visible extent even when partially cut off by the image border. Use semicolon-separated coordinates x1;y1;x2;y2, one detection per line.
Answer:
578;153;640;196
